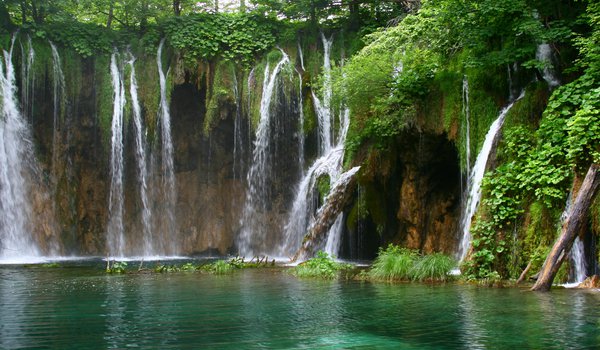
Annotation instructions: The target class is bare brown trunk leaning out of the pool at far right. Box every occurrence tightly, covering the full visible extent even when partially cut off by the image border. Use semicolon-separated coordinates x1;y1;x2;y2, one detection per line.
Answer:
531;164;600;292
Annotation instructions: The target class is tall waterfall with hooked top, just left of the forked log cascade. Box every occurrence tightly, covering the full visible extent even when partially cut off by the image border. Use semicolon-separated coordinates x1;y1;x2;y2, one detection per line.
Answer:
237;50;289;255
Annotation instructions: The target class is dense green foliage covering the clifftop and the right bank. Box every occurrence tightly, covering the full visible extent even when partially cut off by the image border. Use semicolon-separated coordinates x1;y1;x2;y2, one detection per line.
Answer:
0;0;600;279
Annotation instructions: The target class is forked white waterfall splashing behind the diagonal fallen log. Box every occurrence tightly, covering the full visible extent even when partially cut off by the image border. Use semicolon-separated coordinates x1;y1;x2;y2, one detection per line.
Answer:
279;34;354;256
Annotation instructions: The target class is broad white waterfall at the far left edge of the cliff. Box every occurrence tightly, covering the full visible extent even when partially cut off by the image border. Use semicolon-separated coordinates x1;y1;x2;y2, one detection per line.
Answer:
0;35;40;260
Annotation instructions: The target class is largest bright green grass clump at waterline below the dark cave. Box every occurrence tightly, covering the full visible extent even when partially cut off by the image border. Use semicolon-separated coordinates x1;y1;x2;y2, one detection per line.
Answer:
366;244;456;282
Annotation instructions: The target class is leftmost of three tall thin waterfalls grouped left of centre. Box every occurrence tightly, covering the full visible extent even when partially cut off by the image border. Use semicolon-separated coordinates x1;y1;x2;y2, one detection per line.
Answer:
107;52;125;257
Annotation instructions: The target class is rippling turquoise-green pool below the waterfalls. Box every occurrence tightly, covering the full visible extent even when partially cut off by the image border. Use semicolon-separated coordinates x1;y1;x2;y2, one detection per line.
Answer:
0;263;600;349
